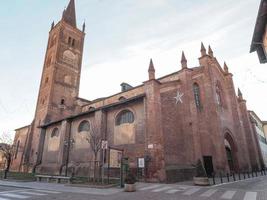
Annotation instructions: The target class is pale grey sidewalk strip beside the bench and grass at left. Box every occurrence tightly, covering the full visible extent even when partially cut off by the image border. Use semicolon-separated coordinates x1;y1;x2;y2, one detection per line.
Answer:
0;180;122;195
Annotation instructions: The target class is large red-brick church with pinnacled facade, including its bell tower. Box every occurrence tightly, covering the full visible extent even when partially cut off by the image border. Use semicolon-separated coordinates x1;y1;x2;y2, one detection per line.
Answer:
11;0;264;182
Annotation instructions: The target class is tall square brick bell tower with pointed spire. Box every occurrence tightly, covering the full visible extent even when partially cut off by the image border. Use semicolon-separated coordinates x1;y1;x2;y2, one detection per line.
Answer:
25;0;85;168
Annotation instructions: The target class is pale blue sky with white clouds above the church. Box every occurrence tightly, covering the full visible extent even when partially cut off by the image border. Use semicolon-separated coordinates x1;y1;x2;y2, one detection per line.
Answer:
0;0;267;138
